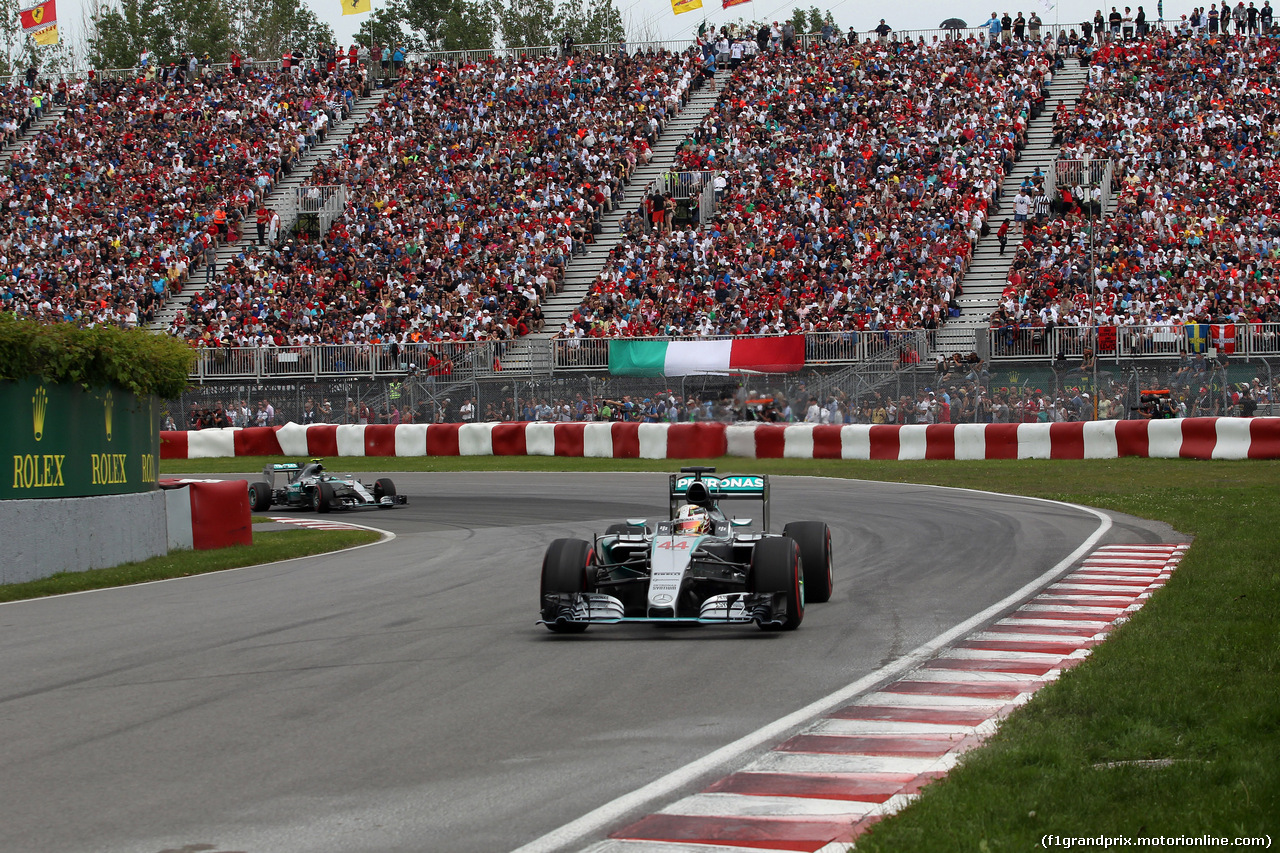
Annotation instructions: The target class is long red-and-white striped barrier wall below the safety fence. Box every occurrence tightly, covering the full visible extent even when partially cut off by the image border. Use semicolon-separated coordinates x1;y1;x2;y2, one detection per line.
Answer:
160;418;1280;460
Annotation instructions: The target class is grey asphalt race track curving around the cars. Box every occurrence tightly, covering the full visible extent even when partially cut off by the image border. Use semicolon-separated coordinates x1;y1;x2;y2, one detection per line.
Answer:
0;474;1172;853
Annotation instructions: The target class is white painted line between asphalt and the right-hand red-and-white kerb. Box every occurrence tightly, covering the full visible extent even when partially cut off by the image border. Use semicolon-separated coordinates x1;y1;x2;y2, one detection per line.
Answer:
512;491;1112;853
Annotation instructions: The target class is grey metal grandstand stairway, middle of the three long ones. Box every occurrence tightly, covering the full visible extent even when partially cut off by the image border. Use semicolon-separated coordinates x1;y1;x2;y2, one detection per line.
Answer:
491;77;719;373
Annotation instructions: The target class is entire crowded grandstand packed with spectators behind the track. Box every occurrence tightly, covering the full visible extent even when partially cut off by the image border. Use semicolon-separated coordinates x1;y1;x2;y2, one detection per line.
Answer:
0;4;1280;425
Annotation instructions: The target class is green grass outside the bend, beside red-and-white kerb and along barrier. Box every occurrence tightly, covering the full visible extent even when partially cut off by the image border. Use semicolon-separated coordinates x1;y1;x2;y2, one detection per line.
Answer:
161;457;1280;835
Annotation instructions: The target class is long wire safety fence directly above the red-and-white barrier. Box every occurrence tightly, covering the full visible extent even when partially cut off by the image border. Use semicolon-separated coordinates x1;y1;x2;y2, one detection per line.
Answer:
165;357;1280;429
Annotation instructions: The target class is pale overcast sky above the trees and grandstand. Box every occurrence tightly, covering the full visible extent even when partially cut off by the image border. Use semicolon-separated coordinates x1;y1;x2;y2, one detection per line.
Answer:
49;0;1182;61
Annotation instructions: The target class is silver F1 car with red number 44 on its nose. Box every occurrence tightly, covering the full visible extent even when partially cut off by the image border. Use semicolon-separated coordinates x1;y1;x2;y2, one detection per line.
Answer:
539;467;832;634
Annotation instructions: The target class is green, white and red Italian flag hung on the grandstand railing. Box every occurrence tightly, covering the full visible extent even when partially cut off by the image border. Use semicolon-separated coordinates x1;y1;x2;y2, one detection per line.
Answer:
609;334;804;377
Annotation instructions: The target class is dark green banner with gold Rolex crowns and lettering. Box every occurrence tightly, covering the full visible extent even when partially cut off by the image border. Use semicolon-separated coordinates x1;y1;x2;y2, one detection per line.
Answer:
0;379;160;501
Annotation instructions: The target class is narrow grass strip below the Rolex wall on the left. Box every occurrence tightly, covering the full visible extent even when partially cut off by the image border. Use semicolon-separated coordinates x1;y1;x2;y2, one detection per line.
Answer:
0;529;380;602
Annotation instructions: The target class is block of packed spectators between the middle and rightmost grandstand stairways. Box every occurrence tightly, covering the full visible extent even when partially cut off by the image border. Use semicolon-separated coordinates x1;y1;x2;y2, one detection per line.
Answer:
559;38;1051;338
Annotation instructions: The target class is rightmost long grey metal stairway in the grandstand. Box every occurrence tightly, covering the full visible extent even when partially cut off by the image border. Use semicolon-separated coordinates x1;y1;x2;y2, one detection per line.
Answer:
934;58;1089;356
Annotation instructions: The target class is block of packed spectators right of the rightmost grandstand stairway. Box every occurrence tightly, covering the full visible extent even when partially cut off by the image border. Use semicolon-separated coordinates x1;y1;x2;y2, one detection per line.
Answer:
992;35;1280;345
